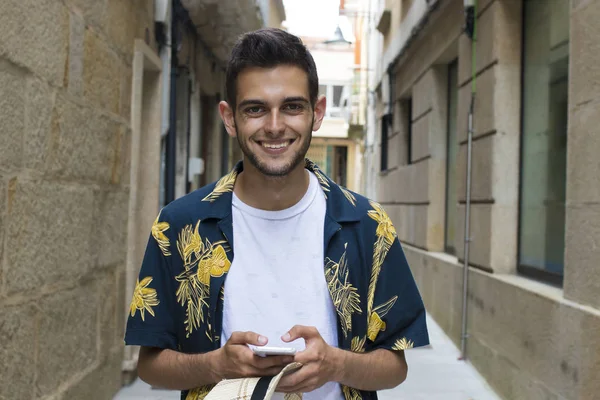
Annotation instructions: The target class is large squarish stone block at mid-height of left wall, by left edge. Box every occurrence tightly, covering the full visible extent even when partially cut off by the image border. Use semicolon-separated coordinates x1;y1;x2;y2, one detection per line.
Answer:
4;178;93;294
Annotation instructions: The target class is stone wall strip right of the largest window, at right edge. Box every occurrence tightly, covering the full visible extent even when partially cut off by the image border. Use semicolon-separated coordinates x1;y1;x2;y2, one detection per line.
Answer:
564;1;600;310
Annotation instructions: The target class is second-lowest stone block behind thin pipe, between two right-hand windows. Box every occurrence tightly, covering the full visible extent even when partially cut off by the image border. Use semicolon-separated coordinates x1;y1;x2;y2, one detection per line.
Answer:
456;135;495;202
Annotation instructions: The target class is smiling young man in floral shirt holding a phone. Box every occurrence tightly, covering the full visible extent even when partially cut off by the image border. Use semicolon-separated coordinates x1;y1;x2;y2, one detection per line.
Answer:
125;29;429;400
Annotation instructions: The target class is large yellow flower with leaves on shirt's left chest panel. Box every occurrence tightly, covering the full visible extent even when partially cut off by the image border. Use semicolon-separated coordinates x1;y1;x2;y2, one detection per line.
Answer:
175;221;231;340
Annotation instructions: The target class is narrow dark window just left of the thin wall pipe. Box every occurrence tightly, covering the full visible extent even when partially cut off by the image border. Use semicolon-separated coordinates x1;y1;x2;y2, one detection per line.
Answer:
444;61;458;254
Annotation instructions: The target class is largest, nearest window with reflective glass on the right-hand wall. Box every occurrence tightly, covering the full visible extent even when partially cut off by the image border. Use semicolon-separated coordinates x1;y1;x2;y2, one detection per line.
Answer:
518;0;570;284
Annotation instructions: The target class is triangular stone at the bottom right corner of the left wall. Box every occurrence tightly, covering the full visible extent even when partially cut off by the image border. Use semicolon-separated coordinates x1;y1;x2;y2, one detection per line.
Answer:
62;351;123;400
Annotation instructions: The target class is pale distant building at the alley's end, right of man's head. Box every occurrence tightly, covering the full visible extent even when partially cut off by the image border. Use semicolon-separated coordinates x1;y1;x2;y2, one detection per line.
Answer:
292;1;366;192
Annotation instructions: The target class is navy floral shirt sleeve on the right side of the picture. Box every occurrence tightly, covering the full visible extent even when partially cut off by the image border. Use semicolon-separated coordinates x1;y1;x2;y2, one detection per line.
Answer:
367;235;429;351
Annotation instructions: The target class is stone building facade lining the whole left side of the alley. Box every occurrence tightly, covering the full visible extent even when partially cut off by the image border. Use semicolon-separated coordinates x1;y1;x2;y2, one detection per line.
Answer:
0;0;284;400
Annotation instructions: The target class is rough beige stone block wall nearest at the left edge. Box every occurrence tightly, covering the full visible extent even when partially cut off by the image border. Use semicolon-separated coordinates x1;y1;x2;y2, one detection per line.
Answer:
0;0;154;399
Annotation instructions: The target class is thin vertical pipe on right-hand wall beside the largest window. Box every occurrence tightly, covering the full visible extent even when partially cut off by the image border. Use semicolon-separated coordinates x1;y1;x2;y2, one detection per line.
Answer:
460;0;477;360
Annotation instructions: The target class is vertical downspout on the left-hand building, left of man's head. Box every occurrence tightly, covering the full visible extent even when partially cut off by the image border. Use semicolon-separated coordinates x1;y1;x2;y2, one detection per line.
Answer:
165;0;180;204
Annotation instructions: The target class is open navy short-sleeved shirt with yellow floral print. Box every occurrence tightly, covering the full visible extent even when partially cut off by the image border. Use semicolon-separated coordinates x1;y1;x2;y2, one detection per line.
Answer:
125;160;429;400
